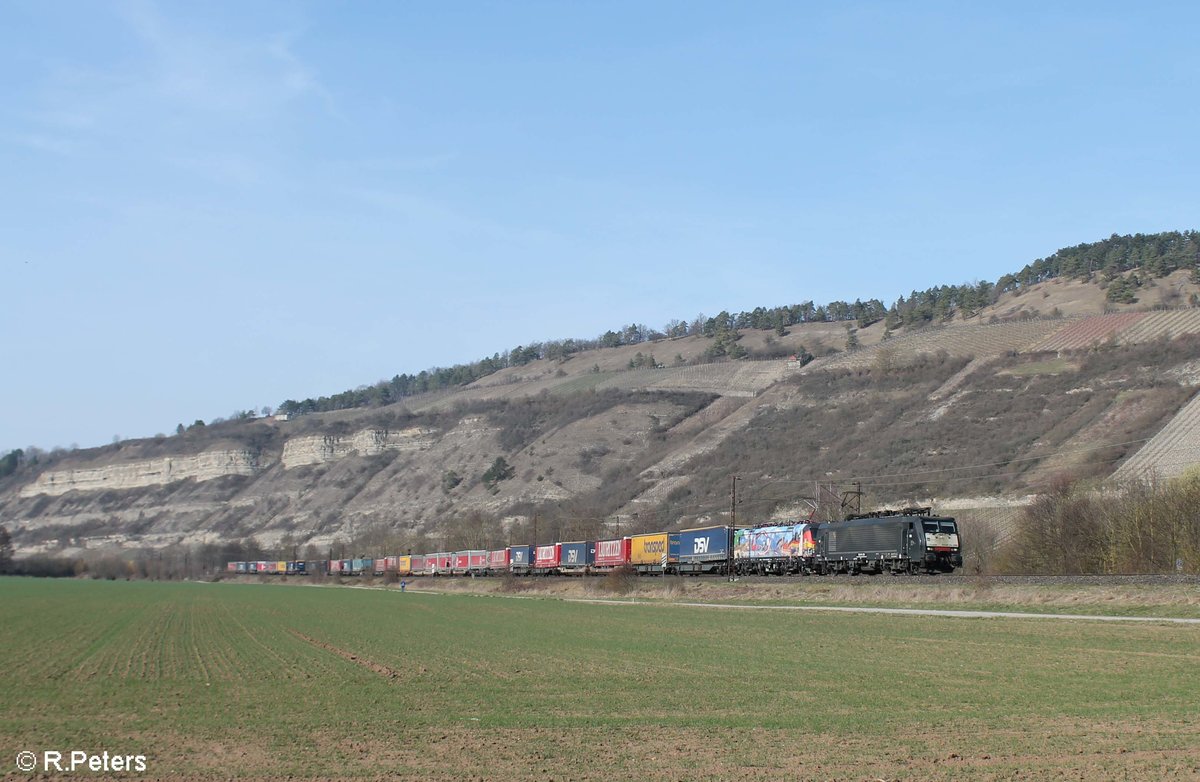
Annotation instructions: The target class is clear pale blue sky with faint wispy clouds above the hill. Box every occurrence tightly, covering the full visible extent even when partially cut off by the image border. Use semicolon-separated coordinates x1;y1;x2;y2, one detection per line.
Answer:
0;0;1200;451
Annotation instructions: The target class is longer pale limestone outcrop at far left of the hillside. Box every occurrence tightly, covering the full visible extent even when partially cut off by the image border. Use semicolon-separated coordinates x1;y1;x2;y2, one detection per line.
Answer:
20;450;259;498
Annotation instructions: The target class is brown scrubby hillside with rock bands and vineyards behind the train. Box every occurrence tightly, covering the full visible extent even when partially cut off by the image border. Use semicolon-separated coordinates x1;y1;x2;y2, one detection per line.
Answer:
7;266;1200;566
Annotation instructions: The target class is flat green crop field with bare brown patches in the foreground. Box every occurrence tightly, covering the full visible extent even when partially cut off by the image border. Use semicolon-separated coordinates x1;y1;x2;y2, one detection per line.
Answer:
0;579;1200;780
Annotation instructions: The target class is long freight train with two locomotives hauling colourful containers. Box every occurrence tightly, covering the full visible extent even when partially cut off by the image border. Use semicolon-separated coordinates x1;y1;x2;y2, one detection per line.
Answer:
227;507;962;577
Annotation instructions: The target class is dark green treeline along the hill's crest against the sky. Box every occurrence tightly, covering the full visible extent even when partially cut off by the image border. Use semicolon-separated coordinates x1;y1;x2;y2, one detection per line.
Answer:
278;230;1200;415
